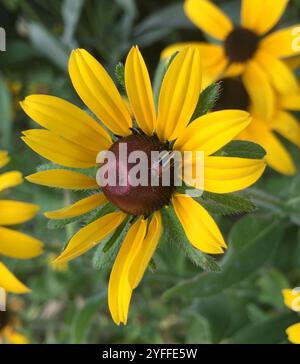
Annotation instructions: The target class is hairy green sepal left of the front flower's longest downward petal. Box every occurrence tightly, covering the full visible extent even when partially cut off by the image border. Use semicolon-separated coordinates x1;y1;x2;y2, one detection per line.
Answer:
93;219;130;270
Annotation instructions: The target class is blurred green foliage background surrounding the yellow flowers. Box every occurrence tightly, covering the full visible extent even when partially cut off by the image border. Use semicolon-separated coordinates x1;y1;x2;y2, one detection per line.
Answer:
0;0;300;343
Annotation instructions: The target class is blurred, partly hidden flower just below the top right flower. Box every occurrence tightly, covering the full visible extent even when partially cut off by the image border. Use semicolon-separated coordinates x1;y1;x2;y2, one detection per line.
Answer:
216;78;300;175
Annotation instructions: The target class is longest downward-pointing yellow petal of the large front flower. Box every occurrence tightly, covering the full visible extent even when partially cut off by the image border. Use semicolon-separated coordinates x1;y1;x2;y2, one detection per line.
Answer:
108;217;147;325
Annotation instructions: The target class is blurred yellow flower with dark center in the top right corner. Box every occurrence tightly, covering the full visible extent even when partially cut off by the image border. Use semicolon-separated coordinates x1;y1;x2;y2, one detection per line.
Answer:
162;0;300;117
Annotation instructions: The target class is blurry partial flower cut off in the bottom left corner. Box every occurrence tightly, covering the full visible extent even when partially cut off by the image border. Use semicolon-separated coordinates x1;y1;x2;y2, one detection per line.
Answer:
0;300;29;344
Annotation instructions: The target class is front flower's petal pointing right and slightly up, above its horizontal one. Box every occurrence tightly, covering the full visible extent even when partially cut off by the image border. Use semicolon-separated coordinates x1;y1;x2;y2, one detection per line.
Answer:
174;110;251;155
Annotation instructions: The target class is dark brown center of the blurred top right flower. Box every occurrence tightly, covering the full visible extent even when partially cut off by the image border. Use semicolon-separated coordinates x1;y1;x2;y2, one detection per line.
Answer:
225;27;259;62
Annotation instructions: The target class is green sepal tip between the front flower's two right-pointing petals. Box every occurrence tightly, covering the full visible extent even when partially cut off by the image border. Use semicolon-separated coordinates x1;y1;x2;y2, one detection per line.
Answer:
214;140;266;159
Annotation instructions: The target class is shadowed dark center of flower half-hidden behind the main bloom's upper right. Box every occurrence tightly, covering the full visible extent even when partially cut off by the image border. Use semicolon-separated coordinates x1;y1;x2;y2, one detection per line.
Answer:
214;78;250;111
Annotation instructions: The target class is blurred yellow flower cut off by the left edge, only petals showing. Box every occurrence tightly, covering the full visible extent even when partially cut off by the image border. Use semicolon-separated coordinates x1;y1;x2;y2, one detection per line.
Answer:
0;151;43;293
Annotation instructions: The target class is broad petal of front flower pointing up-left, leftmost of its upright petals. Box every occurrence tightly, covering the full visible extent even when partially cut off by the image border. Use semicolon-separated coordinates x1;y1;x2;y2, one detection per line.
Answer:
69;49;132;136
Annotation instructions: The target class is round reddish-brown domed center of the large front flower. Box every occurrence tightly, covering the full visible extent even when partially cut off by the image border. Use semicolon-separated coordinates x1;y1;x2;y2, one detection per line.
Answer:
102;134;174;216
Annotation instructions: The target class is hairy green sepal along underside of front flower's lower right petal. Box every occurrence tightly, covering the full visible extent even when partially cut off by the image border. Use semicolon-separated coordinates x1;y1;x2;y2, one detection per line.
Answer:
162;207;221;272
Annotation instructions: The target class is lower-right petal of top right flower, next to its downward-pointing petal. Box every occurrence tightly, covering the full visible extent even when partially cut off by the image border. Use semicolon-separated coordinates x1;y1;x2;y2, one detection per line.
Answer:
256;50;298;94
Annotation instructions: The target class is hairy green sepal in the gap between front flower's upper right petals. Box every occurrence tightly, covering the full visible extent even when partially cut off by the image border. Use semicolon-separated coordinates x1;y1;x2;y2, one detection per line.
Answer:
191;82;221;121
